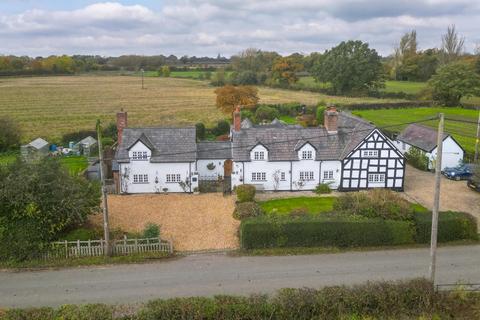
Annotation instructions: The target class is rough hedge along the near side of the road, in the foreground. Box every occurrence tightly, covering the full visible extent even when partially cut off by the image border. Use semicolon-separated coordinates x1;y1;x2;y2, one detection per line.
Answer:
0;279;480;320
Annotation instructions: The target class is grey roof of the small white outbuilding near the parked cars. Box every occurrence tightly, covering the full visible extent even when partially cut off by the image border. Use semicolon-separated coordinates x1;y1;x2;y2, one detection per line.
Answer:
397;123;449;152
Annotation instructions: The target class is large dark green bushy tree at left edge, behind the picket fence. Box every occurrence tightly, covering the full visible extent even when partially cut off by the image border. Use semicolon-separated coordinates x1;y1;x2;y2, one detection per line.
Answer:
0;158;100;260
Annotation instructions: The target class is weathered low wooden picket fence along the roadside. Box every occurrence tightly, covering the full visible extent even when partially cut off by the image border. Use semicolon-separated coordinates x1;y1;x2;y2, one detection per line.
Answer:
44;238;173;259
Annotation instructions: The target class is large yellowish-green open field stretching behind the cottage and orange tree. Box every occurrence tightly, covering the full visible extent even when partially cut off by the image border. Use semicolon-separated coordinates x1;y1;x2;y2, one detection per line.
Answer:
0;76;404;142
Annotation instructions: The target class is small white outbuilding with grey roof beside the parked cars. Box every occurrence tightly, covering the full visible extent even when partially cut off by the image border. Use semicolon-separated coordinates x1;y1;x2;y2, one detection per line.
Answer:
394;124;465;170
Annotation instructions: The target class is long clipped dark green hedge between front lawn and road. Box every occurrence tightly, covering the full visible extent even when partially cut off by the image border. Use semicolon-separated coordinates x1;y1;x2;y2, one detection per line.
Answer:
240;217;414;249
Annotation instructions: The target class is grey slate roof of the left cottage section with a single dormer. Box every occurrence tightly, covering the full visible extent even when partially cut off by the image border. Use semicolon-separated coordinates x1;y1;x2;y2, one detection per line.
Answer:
115;127;197;163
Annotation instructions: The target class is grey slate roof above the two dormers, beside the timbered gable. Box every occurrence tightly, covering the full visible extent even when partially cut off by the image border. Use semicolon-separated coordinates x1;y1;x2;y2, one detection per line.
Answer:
232;112;375;161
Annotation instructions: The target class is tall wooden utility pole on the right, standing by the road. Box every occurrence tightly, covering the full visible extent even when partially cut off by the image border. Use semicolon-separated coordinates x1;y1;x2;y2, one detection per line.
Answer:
430;113;444;287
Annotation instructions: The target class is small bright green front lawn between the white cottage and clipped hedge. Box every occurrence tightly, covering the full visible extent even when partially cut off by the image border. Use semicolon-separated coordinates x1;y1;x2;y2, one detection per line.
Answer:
260;197;335;215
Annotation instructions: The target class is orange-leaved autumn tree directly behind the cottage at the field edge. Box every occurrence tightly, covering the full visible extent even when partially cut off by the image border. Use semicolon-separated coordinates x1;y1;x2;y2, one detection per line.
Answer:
215;85;258;114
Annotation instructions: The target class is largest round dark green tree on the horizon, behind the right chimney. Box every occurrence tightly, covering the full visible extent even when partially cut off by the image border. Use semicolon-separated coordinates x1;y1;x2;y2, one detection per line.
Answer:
313;41;385;94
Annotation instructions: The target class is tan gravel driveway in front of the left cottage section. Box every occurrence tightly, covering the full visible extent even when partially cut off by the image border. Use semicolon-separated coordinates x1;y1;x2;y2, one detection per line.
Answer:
94;193;240;251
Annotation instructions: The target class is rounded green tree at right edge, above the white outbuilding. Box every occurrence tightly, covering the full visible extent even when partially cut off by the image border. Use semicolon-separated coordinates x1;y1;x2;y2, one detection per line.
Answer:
428;61;480;106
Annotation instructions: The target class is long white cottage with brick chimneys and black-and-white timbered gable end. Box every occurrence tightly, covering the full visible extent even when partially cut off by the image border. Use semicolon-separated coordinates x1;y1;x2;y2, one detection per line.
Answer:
116;108;405;193
